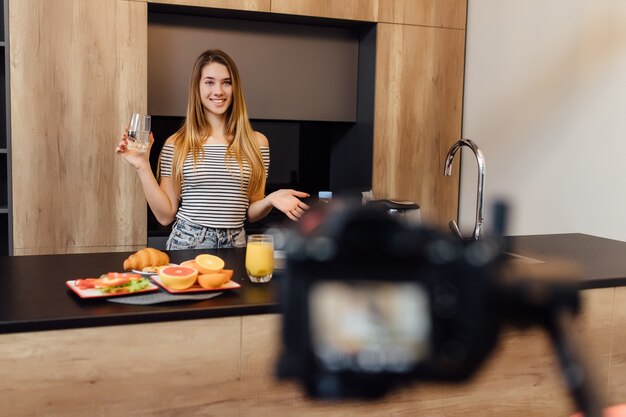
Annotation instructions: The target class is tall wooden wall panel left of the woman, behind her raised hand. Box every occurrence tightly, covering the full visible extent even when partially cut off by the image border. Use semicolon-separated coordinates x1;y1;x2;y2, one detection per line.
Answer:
9;0;147;254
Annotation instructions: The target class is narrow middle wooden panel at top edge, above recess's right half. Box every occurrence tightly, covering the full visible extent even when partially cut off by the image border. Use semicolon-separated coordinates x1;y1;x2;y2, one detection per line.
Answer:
272;0;378;22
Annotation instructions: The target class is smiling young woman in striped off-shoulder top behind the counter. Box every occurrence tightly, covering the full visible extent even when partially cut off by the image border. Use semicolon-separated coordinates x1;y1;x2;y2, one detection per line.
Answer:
116;50;309;249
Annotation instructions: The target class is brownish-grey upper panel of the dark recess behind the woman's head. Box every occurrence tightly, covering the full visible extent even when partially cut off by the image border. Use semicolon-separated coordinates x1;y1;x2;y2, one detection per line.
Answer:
148;13;359;122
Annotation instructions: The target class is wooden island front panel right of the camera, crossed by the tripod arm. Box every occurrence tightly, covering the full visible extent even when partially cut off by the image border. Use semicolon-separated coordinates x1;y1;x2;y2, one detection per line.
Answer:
446;288;614;417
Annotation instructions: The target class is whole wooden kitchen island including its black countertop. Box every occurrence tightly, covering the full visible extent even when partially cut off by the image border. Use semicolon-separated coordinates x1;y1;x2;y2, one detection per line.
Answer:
0;234;626;417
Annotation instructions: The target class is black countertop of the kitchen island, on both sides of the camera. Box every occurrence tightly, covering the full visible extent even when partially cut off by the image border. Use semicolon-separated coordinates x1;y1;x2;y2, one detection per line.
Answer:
0;234;626;333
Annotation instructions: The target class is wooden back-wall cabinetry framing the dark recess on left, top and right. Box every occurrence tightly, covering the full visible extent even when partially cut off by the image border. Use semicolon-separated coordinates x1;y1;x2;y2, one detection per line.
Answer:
6;0;466;255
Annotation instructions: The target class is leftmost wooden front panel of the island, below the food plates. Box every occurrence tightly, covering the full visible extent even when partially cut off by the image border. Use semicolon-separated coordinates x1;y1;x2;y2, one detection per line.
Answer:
0;317;241;417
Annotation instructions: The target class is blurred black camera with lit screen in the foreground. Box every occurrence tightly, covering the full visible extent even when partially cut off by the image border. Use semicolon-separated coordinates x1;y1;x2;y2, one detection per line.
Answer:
277;200;595;407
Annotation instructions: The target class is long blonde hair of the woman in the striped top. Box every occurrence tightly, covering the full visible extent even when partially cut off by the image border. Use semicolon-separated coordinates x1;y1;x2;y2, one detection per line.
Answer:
159;49;266;201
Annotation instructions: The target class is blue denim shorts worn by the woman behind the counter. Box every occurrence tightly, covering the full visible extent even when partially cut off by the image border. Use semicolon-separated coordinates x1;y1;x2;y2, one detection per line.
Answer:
165;219;246;250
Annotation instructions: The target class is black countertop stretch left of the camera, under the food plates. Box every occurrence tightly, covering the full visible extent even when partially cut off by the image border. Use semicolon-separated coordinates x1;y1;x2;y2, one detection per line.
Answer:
0;249;282;333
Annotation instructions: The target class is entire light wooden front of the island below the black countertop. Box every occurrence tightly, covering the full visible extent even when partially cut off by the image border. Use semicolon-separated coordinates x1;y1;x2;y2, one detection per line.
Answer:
0;287;626;417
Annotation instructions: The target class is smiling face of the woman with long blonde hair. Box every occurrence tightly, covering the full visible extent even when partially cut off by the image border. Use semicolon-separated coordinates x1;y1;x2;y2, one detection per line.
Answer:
200;62;233;116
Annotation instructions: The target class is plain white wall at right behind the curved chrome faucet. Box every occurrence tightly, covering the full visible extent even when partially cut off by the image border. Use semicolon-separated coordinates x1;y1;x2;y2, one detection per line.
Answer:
460;0;626;240
